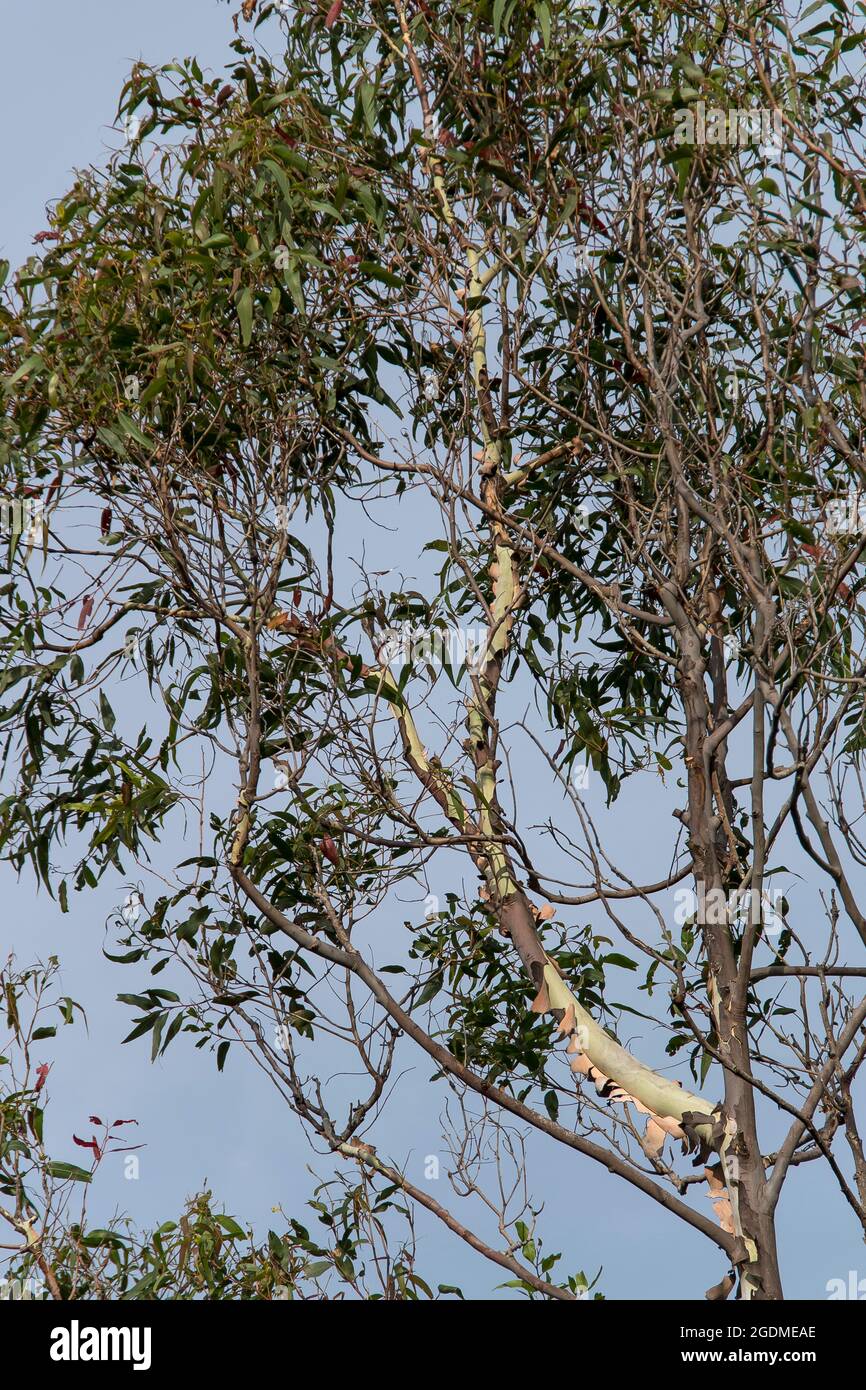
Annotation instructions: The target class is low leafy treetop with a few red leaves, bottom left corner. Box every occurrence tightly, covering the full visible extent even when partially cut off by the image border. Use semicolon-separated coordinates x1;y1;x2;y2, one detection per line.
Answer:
0;958;447;1301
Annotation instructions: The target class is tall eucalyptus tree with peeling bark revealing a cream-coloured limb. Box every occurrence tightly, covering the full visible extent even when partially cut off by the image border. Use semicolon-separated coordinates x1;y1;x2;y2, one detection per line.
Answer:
0;0;866;1300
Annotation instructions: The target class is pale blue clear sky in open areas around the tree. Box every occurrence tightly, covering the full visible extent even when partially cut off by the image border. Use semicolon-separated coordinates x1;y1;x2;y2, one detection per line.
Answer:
0;0;866;1298
